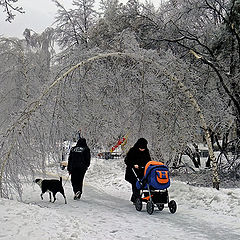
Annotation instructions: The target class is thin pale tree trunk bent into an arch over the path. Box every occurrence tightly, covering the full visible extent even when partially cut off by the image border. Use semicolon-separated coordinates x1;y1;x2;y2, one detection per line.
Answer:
0;52;220;195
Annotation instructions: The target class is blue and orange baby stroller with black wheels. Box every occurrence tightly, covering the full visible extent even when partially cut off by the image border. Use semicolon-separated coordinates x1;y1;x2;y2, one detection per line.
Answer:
133;161;177;214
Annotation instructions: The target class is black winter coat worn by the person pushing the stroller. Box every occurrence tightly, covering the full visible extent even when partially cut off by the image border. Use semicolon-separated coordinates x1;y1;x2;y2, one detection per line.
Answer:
124;139;151;184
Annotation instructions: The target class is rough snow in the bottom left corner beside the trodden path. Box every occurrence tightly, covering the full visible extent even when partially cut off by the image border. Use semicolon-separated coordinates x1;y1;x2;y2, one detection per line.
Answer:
0;199;91;240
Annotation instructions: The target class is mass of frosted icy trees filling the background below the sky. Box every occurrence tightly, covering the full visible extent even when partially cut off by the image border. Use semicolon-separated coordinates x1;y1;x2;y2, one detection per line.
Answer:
0;0;240;196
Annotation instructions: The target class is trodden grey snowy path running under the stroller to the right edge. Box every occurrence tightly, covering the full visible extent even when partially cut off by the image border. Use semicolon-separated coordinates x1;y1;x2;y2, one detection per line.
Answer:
63;183;240;240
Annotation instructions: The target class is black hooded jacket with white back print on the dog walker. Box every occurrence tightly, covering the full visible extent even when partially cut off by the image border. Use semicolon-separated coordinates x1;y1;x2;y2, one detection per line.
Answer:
67;138;91;174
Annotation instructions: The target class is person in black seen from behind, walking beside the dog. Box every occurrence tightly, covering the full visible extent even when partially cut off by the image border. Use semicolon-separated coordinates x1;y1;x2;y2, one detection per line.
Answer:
67;138;91;200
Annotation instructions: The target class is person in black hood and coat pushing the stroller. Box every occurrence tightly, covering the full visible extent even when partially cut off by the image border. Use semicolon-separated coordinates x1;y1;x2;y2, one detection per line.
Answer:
124;138;151;203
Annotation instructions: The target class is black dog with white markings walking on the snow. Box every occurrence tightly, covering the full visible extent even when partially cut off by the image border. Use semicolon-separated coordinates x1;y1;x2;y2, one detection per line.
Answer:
34;177;67;203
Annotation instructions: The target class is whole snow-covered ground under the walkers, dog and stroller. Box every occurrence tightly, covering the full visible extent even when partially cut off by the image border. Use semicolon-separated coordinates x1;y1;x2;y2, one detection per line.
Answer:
0;159;240;240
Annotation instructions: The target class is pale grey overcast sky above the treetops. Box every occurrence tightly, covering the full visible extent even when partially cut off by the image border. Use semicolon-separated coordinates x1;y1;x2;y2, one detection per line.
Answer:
0;0;160;38
